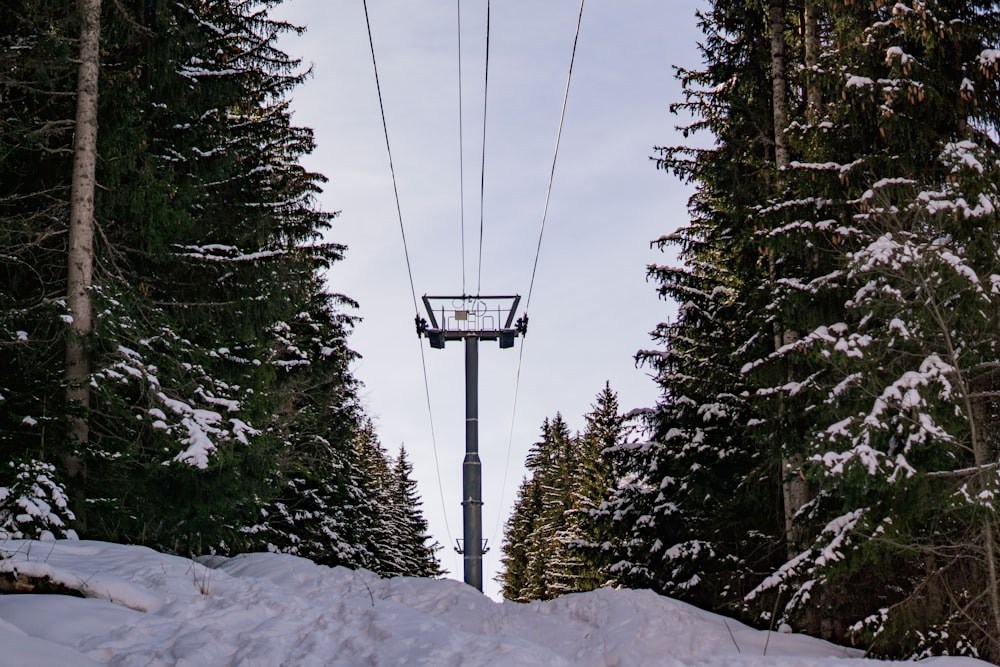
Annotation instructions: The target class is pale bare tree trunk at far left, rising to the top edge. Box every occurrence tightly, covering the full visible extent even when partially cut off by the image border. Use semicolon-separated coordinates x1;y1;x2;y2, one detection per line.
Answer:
66;0;101;477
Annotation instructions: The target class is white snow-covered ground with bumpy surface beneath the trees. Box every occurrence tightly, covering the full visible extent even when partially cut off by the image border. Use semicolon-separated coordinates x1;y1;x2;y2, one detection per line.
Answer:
0;541;987;667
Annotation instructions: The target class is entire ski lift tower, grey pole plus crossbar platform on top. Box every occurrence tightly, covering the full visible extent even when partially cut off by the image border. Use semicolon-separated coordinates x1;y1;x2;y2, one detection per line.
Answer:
416;295;528;592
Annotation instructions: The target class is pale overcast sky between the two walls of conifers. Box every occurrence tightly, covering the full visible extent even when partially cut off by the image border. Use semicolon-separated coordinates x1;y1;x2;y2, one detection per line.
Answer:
275;0;704;597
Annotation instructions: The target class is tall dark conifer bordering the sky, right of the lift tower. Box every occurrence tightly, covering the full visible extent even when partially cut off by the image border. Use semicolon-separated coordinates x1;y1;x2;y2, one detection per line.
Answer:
611;2;788;609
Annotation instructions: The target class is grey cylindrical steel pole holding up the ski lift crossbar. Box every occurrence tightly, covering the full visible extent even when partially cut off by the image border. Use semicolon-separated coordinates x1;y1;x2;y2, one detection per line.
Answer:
462;336;483;592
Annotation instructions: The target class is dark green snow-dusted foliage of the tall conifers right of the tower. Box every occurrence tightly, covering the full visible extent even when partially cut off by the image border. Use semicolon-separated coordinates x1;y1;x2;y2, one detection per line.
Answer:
628;0;1000;659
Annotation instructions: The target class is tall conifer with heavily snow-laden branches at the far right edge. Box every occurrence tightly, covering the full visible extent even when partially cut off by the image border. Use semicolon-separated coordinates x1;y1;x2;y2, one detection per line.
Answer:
744;2;1000;658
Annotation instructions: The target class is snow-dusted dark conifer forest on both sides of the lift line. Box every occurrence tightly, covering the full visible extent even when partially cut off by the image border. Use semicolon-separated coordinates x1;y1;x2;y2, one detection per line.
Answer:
0;0;1000;663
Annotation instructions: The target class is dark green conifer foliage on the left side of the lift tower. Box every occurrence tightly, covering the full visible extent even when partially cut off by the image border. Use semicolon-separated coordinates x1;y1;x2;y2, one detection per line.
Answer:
0;0;437;574
